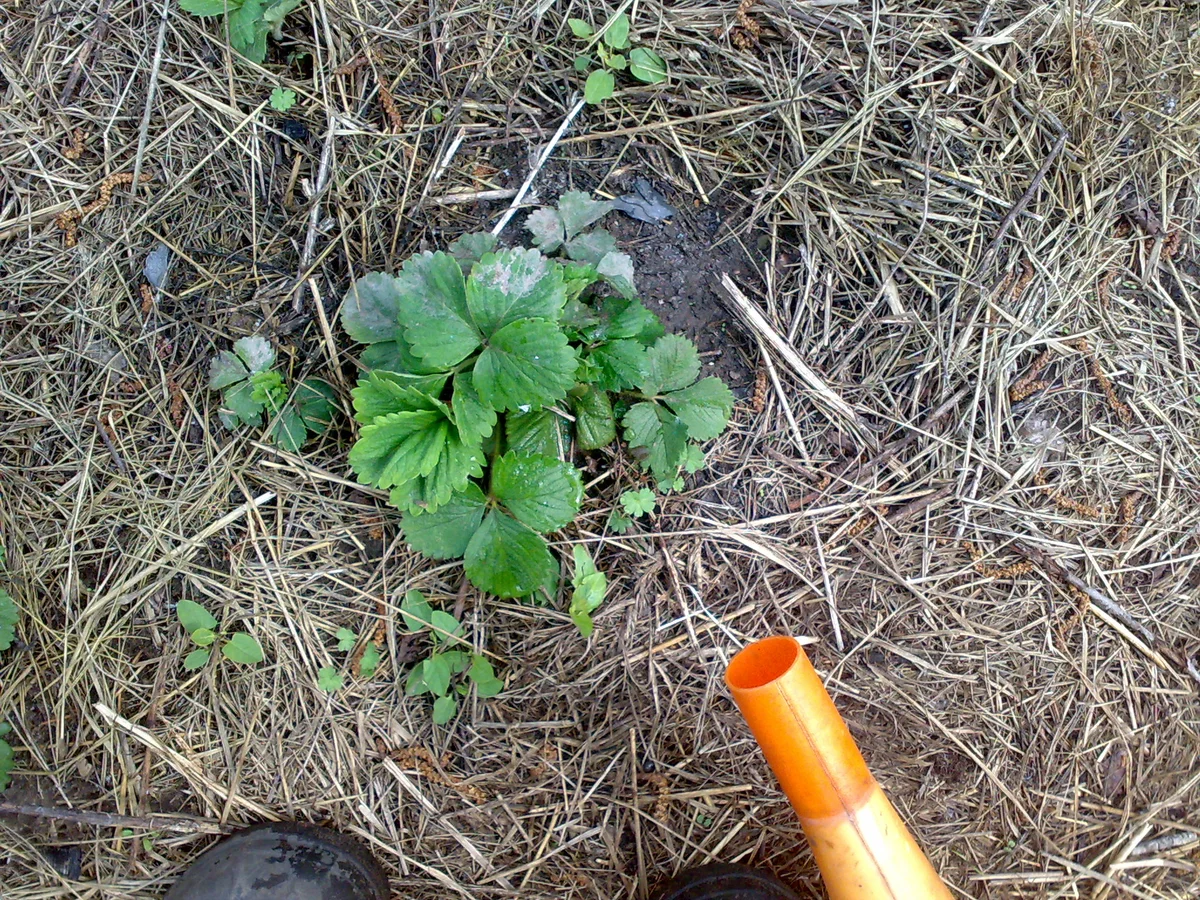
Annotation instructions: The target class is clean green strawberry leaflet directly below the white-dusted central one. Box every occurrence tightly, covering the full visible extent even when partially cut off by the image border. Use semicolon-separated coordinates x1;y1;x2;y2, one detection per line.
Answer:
474;319;578;412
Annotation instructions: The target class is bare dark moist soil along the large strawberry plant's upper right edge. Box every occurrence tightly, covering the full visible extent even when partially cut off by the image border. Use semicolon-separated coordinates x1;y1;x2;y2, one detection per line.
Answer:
485;148;758;397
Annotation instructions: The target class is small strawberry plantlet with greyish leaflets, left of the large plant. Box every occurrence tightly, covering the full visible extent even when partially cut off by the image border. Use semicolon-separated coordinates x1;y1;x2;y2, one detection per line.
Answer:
209;337;337;452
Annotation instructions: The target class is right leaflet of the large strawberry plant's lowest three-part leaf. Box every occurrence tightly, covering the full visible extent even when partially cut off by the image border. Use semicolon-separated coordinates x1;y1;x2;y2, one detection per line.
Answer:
492;452;583;533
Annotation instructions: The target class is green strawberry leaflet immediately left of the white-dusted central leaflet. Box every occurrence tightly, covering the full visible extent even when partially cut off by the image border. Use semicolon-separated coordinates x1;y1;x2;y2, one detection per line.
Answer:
396;253;481;367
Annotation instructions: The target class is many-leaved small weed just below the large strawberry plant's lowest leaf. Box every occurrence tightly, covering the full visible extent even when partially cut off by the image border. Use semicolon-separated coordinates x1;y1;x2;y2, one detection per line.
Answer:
400;590;504;725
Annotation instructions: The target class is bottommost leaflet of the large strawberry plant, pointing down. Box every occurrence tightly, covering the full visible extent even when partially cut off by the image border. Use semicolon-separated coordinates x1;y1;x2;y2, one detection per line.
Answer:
463;510;558;598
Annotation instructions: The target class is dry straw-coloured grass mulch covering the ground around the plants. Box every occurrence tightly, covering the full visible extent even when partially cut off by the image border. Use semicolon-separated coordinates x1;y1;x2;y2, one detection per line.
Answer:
0;0;1200;900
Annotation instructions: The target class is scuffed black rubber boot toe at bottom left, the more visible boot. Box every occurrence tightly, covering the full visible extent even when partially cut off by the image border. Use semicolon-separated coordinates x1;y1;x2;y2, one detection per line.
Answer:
163;822;389;900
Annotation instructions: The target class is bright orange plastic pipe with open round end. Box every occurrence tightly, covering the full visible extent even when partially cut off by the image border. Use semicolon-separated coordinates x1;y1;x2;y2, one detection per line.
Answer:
725;637;950;900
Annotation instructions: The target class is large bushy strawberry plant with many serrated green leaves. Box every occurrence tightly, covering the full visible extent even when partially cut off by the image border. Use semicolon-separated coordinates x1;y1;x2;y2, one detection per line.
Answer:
341;192;733;608
